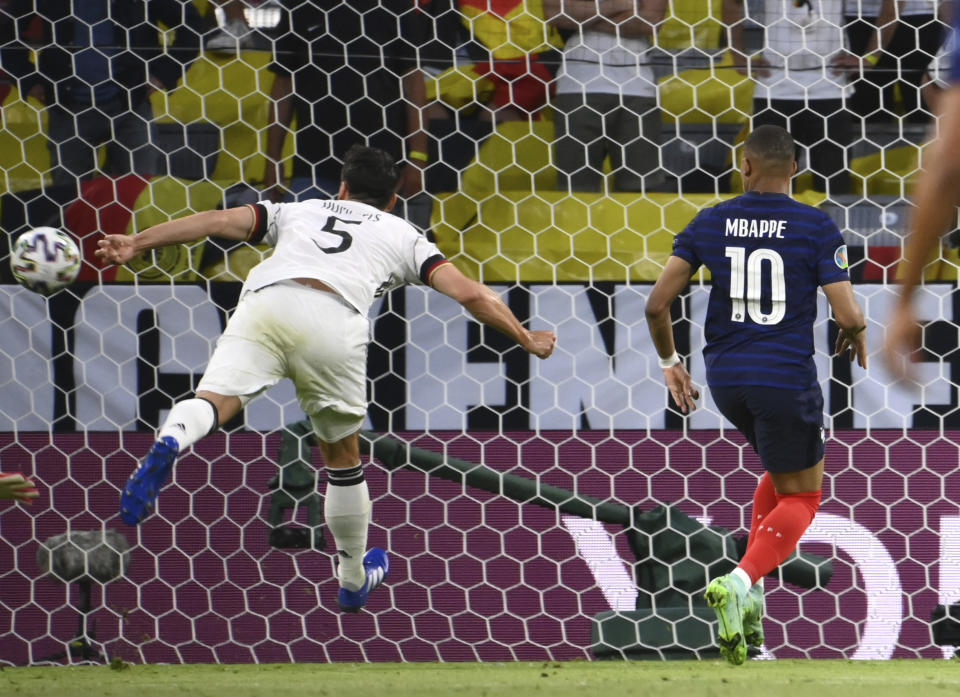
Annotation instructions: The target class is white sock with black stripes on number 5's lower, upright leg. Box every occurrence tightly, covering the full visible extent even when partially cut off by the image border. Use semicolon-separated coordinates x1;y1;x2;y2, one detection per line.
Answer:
323;465;371;591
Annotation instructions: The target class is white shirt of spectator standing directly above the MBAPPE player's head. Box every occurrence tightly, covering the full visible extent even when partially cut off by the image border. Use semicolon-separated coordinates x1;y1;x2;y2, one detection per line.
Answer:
747;0;851;101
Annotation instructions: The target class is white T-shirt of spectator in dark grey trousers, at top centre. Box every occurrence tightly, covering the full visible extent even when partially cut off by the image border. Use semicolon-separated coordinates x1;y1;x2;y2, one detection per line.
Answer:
556;0;657;97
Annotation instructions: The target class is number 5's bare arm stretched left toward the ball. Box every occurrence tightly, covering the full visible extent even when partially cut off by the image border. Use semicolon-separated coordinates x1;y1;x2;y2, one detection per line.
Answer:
96;206;256;266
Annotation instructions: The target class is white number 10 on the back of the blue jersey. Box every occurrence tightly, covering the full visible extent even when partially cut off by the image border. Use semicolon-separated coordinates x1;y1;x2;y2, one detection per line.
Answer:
724;247;787;325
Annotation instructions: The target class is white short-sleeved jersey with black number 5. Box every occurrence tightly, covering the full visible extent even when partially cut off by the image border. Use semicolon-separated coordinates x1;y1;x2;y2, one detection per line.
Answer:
243;199;446;315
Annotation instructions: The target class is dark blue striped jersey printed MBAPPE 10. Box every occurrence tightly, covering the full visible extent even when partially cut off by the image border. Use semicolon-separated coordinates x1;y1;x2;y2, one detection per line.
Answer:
673;192;850;389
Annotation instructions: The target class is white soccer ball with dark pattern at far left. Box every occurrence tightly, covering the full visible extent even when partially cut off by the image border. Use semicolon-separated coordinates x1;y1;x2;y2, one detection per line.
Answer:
10;227;81;295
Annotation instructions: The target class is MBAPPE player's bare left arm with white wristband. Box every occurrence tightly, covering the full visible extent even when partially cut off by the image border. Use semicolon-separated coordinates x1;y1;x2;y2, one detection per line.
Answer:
645;256;700;414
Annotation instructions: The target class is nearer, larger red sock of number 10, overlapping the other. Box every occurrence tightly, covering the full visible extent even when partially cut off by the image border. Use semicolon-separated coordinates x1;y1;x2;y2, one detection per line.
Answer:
738;491;822;583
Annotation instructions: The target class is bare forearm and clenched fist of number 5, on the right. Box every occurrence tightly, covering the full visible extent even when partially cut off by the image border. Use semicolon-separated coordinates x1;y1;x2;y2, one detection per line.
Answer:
430;264;557;358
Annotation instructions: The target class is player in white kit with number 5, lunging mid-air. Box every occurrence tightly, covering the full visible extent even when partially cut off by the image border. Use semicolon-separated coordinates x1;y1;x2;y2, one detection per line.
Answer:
97;145;556;612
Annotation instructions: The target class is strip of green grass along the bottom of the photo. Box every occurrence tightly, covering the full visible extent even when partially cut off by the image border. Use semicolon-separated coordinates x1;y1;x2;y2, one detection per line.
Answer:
0;660;960;697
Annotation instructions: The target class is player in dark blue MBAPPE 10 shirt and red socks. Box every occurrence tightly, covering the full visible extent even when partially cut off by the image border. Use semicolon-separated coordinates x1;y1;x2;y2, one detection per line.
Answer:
646;125;867;665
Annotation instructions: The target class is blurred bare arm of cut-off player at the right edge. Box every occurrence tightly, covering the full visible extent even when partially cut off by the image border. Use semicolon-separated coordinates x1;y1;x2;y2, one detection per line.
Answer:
883;9;960;378
